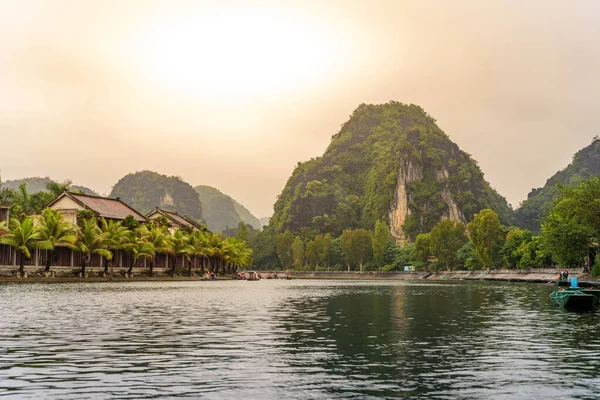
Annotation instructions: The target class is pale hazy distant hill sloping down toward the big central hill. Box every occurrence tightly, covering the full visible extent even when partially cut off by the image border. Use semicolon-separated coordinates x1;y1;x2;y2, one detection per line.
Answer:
194;185;261;232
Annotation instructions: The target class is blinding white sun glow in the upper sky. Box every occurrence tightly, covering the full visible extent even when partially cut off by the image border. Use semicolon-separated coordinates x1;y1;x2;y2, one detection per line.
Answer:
133;8;343;103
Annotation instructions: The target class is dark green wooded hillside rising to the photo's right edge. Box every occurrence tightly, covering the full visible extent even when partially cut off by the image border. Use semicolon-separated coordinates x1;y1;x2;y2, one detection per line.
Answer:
516;138;600;233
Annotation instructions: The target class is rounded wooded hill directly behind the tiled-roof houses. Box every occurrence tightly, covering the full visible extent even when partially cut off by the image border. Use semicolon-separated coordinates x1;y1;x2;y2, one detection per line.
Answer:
110;171;203;221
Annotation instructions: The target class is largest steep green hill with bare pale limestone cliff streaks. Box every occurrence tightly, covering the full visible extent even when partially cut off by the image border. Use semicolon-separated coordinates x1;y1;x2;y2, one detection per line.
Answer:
270;102;514;242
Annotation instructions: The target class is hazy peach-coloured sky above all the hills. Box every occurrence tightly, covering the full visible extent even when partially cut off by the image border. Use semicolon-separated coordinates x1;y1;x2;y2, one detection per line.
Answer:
0;0;600;217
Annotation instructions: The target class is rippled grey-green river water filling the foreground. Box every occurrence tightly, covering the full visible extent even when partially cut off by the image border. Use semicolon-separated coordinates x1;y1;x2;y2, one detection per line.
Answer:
0;280;600;399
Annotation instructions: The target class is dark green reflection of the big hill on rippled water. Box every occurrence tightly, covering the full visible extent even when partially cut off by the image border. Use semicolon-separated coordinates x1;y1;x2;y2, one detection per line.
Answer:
281;283;504;396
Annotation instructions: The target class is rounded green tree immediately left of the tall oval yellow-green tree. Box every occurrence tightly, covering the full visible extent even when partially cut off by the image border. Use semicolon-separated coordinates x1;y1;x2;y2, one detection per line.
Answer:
430;219;468;270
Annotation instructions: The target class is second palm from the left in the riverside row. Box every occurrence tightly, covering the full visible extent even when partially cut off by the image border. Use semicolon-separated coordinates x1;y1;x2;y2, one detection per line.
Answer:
37;208;77;273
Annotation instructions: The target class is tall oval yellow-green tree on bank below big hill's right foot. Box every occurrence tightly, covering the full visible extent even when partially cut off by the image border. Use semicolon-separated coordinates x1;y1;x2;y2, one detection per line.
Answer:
467;208;502;268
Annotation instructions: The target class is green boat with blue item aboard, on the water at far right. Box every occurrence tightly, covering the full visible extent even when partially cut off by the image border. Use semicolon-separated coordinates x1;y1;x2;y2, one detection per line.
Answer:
550;278;600;312
